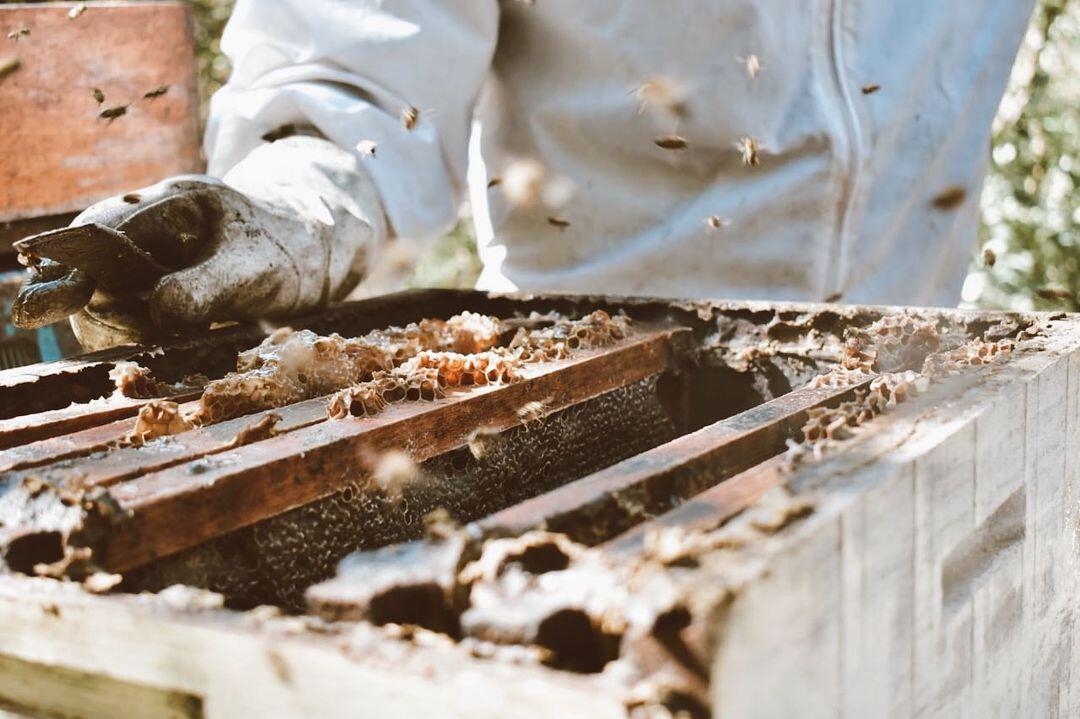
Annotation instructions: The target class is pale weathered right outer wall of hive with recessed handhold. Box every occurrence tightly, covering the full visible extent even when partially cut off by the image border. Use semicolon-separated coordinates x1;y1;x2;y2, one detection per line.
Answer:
712;317;1080;719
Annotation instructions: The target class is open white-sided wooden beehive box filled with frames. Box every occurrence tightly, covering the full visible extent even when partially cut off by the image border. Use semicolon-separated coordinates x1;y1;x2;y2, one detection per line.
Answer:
0;290;1080;717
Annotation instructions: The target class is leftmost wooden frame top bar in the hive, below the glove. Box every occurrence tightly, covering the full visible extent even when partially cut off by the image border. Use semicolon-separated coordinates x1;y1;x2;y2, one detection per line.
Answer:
0;390;202;449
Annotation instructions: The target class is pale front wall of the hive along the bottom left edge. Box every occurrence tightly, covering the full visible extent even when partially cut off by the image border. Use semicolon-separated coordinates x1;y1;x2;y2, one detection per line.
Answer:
0;576;625;719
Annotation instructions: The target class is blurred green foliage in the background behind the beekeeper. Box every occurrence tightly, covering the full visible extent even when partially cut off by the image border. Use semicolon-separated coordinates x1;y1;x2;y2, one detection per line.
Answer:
190;0;1080;302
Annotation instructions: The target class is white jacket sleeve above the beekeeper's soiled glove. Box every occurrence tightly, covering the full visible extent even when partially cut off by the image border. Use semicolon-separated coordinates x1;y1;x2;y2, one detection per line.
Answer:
205;0;499;241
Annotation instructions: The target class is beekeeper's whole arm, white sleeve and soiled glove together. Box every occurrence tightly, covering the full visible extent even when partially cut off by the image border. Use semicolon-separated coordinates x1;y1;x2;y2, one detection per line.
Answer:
16;0;498;348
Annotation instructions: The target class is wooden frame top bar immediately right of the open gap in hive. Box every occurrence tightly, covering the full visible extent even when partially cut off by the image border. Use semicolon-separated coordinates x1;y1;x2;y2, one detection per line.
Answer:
477;380;870;544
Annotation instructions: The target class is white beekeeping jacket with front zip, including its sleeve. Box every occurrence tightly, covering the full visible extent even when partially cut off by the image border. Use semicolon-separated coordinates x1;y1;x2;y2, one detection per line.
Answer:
206;0;1034;306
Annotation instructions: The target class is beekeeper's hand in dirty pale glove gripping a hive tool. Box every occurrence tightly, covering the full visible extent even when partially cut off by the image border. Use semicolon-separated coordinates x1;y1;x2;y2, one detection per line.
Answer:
13;137;383;350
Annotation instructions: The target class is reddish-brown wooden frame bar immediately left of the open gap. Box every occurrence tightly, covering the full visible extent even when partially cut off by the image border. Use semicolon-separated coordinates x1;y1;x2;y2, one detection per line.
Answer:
94;330;685;571
